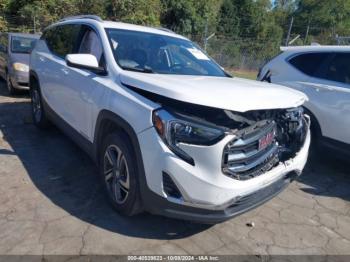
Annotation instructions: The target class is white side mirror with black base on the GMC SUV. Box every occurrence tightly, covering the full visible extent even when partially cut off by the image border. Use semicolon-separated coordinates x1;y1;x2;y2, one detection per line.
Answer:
66;54;107;75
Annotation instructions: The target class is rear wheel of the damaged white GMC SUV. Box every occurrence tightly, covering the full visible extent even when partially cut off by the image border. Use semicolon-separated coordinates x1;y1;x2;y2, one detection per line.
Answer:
30;81;49;129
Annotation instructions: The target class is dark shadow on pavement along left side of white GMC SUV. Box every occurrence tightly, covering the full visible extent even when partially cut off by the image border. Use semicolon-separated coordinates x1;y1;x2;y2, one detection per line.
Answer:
0;81;209;239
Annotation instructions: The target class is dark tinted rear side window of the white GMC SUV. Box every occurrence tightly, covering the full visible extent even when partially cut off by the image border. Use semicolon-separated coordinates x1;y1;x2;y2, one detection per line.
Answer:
43;25;80;58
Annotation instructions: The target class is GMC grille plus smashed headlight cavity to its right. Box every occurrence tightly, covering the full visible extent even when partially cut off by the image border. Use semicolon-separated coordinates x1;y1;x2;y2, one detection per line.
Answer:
222;107;309;180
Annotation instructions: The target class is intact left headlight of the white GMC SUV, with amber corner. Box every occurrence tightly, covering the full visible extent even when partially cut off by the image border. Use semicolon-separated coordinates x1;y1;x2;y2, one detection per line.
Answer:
152;109;225;165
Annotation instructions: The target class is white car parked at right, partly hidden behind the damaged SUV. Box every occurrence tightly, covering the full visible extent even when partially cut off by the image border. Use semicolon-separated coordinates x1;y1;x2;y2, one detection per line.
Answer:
258;46;350;155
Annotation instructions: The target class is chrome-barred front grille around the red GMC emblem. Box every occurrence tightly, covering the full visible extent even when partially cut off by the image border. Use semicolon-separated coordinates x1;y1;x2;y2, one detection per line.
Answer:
222;121;279;180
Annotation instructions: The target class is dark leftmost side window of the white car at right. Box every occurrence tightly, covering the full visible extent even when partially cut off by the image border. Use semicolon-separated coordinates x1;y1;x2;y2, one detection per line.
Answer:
289;53;331;76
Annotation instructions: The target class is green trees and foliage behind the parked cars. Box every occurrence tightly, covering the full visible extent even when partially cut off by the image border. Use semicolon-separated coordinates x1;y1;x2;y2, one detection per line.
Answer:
0;0;350;69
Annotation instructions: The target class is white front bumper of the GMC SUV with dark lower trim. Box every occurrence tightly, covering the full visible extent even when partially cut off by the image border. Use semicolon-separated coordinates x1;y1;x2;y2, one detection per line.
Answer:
139;119;311;223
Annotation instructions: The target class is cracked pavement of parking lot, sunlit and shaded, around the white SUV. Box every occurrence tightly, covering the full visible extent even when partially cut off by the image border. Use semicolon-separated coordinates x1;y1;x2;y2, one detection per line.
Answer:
0;81;350;255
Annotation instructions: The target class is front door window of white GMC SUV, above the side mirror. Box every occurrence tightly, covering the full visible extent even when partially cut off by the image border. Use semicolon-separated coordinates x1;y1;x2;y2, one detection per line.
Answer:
78;26;103;64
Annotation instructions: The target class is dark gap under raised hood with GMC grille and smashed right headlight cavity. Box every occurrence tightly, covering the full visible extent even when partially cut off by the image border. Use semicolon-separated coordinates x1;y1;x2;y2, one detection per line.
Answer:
163;103;309;180
